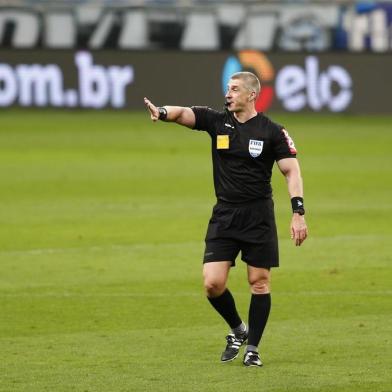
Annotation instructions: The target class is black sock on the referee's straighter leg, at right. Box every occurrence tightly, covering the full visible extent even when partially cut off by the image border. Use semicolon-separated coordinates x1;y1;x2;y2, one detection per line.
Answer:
248;293;271;347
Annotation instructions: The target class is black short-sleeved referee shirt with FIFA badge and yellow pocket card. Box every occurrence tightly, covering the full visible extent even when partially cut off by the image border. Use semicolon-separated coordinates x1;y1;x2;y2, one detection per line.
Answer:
192;106;297;204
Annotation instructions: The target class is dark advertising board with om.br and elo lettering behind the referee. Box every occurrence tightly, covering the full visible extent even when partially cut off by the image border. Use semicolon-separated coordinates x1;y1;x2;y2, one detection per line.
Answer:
0;50;392;113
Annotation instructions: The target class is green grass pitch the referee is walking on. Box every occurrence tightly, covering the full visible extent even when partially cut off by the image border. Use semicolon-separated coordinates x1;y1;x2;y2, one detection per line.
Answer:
0;110;392;392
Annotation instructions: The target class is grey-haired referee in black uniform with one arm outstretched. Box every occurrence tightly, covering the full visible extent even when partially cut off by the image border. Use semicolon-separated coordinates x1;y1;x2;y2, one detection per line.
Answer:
144;72;307;366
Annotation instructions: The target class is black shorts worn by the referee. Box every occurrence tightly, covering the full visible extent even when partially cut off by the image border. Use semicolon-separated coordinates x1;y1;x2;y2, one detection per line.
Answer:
203;199;279;268
